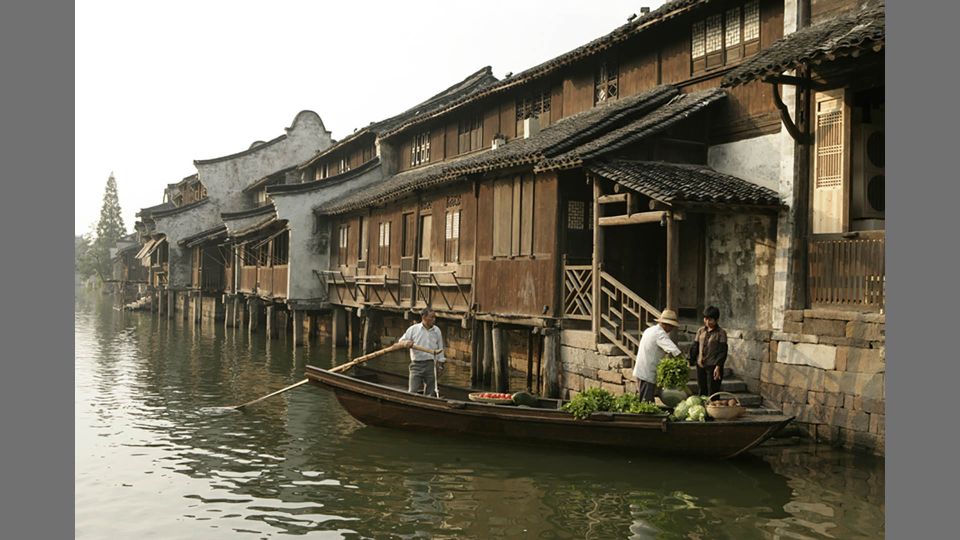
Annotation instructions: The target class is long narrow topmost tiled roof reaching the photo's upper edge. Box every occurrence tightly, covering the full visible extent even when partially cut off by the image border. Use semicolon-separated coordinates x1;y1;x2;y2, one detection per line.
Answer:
381;0;711;138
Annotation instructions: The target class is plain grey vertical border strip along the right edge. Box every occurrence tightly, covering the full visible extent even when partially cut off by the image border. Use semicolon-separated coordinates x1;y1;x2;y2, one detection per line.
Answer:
885;1;960;538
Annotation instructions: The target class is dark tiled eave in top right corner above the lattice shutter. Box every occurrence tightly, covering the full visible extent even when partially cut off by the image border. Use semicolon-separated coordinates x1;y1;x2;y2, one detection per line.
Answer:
723;3;886;86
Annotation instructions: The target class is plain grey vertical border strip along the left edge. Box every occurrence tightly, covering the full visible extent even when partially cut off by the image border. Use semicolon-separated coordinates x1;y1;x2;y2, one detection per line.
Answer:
0;0;74;538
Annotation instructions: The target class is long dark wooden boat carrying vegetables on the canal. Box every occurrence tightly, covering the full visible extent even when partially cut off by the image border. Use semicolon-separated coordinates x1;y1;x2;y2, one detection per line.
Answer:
306;365;793;458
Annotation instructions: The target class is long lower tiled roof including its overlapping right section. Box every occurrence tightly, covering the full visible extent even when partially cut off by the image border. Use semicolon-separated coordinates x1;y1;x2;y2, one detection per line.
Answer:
315;85;725;214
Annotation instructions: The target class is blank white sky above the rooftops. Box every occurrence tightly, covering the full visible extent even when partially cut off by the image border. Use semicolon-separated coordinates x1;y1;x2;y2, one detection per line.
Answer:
74;0;663;234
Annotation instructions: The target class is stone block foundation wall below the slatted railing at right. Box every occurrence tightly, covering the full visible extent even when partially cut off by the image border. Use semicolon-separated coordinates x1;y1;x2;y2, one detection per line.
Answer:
760;310;886;455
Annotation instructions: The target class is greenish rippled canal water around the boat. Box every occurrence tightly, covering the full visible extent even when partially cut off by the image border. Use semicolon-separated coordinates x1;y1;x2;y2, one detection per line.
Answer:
74;293;884;540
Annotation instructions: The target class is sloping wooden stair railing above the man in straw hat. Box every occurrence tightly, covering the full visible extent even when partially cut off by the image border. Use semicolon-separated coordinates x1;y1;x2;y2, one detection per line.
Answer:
598;271;660;356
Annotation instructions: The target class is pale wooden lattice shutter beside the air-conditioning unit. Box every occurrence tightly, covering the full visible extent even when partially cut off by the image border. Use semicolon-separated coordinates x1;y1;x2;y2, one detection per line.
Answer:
812;88;850;234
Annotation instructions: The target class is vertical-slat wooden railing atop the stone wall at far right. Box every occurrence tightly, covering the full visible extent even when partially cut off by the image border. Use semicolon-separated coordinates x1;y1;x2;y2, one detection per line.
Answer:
807;231;887;311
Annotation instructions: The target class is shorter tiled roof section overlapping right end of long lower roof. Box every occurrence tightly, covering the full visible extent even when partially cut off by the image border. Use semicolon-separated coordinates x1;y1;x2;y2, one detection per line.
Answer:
536;88;726;171
